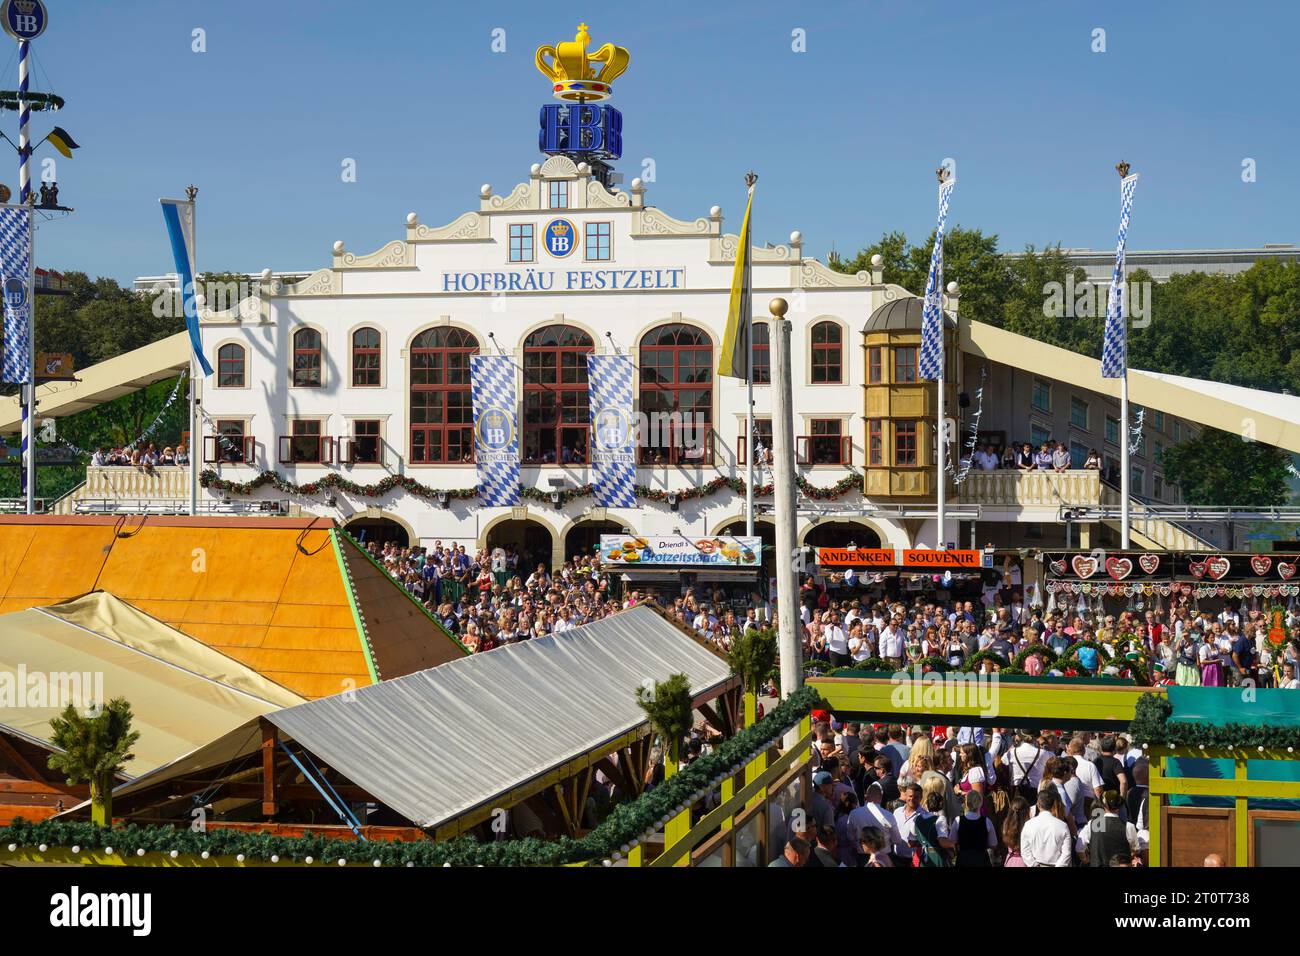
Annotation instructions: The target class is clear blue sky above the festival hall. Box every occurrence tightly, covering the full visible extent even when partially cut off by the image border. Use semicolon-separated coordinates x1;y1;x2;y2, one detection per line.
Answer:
17;0;1300;282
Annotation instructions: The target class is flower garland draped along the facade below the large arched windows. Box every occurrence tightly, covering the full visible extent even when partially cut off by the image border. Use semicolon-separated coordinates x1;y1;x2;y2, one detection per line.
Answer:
199;468;862;505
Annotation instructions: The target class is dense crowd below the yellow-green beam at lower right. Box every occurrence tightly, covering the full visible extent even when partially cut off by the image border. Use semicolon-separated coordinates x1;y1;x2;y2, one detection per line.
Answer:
768;713;1149;868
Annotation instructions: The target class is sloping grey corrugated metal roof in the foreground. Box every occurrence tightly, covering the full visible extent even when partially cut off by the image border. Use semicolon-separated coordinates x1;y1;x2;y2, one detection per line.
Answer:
268;607;731;827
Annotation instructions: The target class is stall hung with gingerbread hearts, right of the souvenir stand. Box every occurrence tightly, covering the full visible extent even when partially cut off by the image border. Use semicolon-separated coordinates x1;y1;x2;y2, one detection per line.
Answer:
1041;549;1300;624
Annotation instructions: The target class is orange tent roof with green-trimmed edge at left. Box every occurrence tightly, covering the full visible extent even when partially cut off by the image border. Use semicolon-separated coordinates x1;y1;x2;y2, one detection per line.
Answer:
0;515;464;697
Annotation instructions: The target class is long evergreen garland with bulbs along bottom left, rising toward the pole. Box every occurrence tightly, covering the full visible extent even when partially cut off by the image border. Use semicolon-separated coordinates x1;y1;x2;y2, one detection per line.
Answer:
0;687;826;866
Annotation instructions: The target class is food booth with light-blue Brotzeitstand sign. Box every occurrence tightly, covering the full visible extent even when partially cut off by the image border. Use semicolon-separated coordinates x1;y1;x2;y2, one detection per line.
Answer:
601;535;768;611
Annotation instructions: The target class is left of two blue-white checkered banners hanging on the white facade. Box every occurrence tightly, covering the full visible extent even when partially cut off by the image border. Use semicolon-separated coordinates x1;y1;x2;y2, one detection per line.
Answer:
469;355;519;507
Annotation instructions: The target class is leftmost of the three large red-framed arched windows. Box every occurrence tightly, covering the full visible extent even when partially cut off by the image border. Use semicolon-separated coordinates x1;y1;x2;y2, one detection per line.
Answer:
411;326;478;464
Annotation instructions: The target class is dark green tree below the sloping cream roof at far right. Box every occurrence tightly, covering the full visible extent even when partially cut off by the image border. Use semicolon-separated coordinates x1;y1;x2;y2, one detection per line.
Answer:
1162;428;1291;507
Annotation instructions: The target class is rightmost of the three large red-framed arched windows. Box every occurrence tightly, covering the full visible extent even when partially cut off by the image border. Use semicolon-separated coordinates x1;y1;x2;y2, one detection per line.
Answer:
640;323;714;464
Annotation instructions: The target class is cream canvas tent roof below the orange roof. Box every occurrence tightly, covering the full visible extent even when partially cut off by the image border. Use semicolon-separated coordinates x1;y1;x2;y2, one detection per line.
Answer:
0;592;303;777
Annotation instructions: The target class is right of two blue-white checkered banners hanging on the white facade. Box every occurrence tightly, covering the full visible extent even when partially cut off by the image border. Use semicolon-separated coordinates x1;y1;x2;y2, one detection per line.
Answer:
586;355;637;507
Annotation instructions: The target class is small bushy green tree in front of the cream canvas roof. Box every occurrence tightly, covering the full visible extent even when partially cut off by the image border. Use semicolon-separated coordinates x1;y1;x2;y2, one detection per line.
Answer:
49;697;140;826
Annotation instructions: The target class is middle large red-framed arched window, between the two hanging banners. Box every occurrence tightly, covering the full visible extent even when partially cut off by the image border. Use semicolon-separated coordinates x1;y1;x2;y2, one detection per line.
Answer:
523;325;595;464
